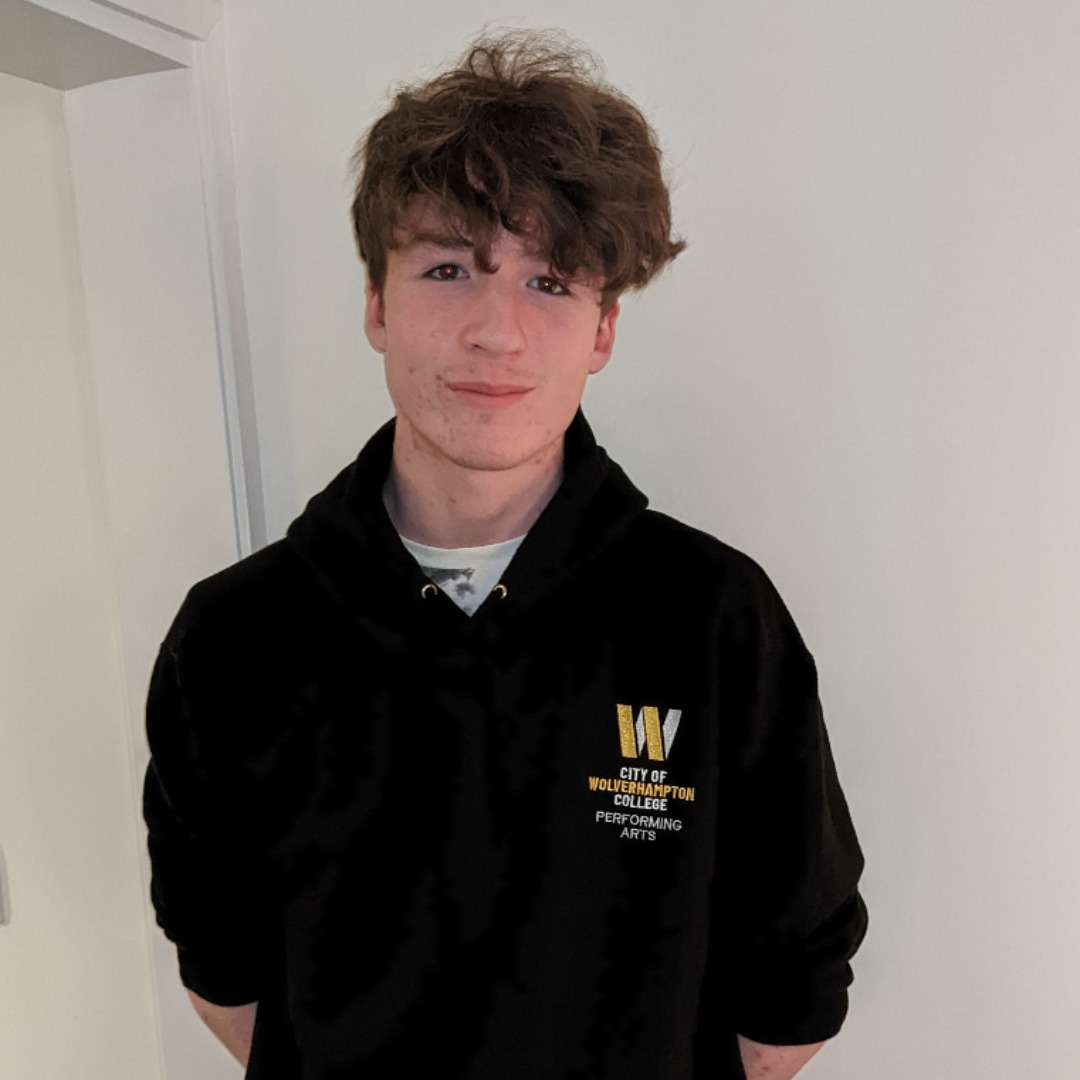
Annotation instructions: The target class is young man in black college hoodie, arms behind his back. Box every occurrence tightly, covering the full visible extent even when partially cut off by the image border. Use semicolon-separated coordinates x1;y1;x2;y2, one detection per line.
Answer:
146;36;865;1080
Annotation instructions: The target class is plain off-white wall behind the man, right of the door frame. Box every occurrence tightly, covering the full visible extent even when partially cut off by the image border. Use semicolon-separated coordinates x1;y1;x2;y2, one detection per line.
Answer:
219;0;1080;1080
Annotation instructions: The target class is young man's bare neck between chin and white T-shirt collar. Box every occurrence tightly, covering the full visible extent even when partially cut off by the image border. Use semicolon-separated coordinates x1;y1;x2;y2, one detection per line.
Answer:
382;427;563;548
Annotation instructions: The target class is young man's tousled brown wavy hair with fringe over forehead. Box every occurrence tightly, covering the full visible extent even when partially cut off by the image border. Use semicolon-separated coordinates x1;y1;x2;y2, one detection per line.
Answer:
352;31;686;309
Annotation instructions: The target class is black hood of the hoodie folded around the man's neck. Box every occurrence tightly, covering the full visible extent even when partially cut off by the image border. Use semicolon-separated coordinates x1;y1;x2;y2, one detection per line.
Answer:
286;410;648;616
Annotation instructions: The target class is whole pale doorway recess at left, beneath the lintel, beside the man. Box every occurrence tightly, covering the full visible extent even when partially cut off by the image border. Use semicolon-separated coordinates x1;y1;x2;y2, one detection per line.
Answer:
0;48;250;1080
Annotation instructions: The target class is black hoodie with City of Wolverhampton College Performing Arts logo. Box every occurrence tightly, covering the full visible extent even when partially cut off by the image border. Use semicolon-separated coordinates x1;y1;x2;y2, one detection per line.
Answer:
146;415;865;1080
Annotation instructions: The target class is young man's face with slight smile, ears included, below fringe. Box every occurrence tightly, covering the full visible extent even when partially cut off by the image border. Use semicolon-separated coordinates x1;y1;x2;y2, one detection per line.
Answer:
365;213;618;470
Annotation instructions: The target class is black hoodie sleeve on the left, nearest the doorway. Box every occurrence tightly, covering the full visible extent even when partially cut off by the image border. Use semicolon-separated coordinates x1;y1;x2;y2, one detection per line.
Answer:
144;644;271;1005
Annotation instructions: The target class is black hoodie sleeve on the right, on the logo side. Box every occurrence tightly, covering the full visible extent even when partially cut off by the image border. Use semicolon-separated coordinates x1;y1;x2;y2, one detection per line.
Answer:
723;573;866;1045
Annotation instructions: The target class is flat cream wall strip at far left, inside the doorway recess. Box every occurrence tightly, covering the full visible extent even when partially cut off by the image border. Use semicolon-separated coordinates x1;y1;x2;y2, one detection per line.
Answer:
0;75;162;1080
